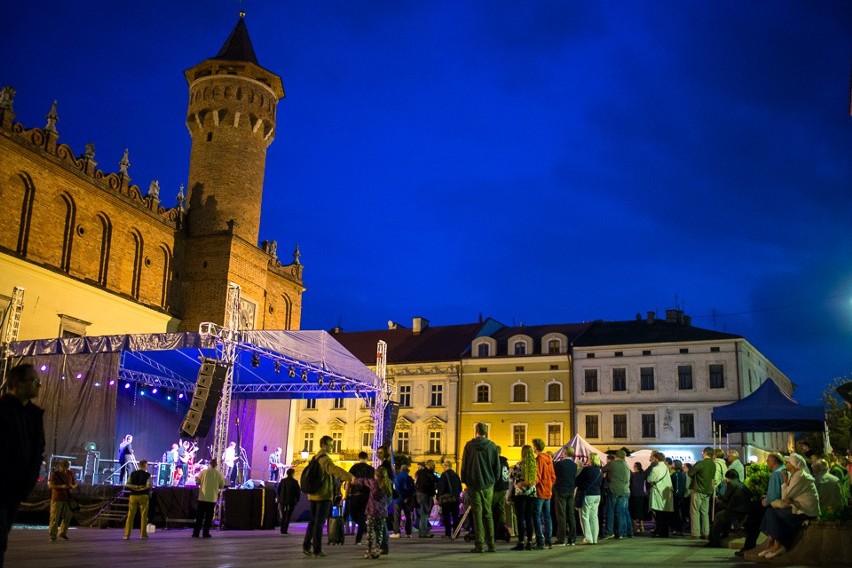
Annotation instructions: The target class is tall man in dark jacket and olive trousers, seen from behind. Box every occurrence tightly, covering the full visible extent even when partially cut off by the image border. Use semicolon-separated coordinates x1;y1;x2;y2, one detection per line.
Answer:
461;422;500;552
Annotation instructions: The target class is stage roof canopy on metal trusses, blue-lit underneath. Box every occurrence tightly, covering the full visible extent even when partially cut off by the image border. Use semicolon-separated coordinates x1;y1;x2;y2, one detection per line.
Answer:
10;324;382;398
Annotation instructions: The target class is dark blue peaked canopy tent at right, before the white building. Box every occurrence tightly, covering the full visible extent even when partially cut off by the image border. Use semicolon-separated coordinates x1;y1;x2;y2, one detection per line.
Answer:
713;379;825;435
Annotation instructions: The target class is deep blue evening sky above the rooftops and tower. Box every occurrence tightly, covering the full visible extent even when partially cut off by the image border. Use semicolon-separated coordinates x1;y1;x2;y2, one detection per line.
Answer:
0;0;852;402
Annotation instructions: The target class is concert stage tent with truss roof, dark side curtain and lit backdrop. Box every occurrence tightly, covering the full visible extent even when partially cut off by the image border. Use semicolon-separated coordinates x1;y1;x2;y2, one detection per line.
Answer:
9;324;386;480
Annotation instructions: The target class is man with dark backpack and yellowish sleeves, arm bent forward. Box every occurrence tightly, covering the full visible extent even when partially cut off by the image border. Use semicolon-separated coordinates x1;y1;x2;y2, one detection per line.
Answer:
301;436;353;557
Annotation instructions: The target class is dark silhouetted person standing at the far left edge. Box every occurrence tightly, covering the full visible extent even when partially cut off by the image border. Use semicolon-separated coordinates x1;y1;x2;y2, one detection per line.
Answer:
0;364;44;566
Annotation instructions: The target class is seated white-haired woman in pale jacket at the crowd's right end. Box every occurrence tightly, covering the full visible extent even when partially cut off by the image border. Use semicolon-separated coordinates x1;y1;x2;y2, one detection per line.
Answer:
758;454;819;558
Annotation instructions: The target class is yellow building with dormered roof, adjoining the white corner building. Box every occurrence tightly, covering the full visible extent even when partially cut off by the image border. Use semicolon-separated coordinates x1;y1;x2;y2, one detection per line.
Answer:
457;324;588;463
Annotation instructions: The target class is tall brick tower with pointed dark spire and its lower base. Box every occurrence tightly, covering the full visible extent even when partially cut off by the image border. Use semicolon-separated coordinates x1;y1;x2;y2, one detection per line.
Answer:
177;14;304;330
